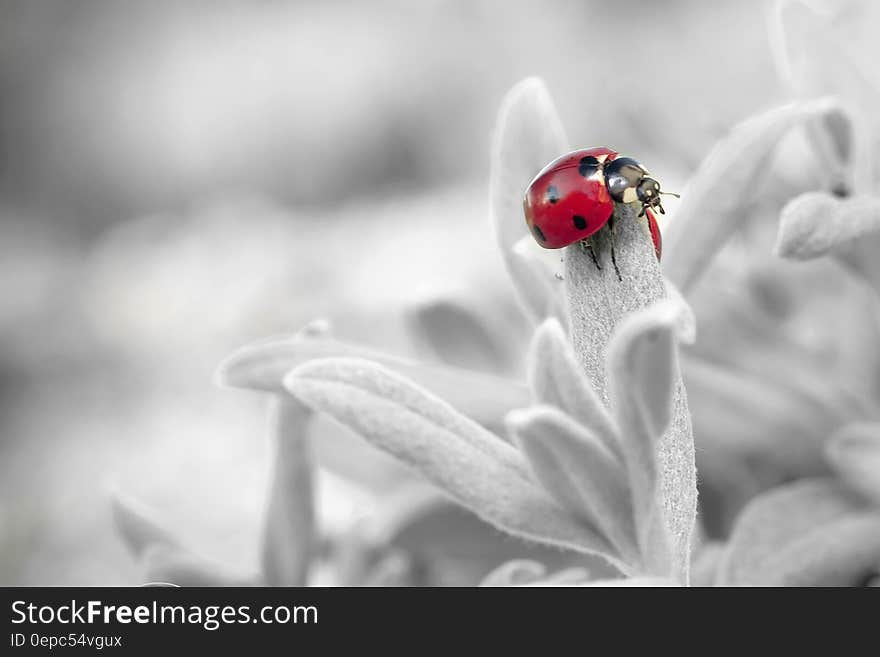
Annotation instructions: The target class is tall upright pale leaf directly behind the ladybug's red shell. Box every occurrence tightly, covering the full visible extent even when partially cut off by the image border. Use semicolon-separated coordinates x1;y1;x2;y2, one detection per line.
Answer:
489;78;567;321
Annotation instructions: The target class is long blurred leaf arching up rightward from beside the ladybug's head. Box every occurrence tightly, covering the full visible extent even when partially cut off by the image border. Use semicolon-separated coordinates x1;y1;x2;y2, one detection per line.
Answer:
663;100;836;295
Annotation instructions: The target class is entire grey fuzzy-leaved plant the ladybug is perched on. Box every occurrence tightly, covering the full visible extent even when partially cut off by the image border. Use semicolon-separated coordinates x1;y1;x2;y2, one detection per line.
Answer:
108;2;880;585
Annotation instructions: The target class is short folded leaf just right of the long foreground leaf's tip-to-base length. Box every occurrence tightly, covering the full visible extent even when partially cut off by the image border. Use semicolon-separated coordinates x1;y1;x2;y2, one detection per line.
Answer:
507;406;639;569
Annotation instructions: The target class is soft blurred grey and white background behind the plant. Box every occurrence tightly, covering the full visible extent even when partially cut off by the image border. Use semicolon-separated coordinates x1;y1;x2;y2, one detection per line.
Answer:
0;0;784;585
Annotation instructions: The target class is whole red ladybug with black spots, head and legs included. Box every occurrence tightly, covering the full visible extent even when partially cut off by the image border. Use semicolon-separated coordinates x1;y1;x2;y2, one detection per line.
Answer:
523;147;677;277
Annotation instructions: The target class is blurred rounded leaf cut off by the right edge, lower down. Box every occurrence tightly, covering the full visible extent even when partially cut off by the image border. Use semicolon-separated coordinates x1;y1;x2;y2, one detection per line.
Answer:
825;423;880;505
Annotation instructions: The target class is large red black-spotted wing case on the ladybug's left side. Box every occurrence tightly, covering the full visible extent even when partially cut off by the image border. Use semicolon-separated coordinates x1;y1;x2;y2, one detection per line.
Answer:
523;147;620;249
